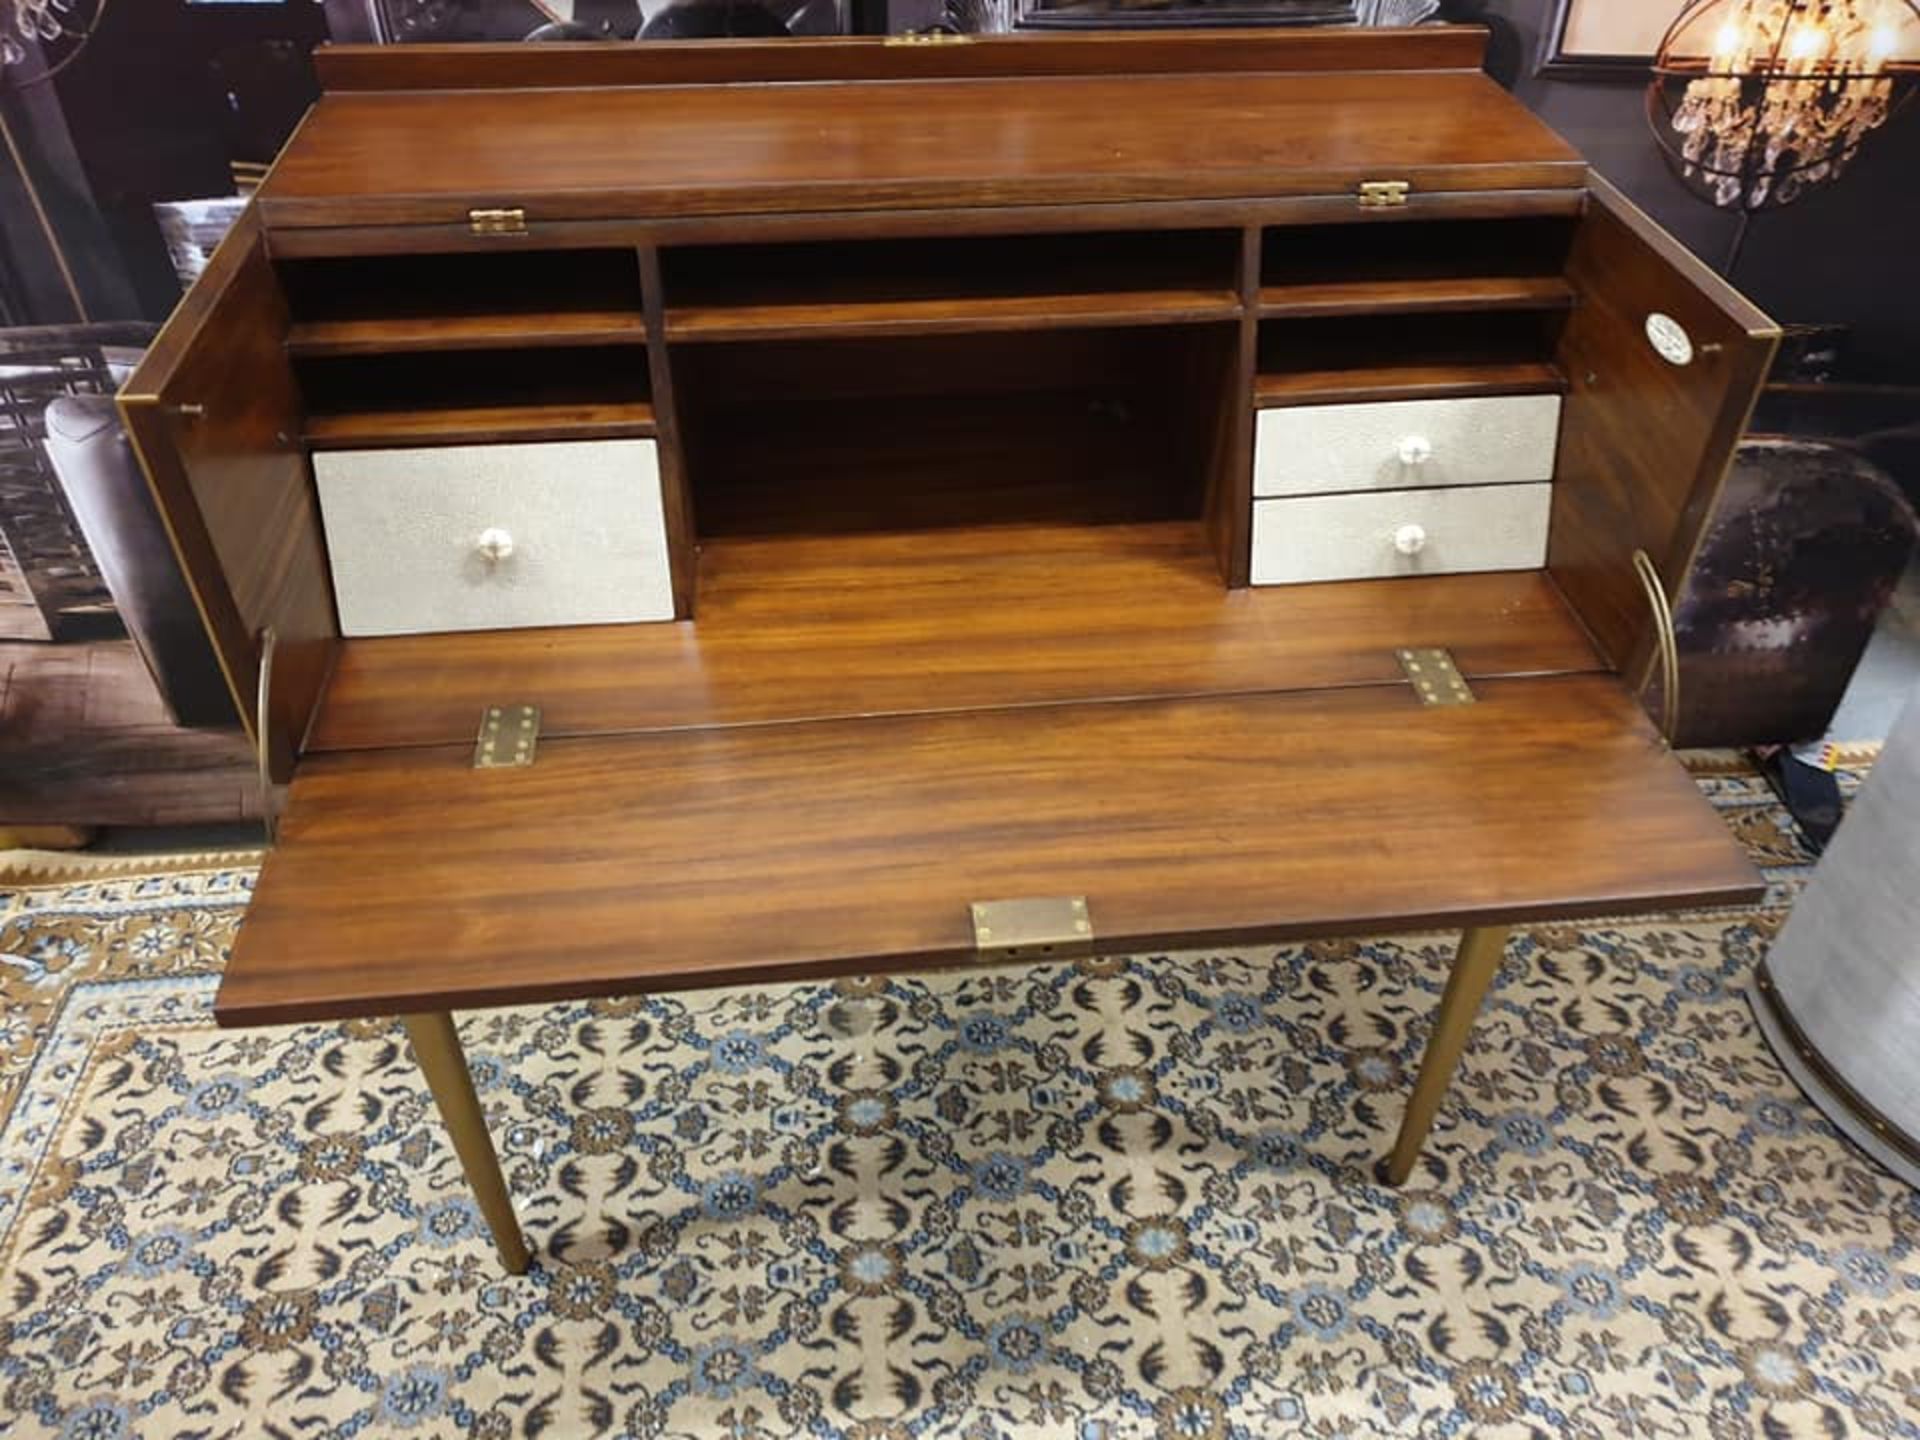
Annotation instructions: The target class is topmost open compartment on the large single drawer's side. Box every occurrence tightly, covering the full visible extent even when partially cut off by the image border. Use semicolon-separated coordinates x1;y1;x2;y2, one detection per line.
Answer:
278;250;645;355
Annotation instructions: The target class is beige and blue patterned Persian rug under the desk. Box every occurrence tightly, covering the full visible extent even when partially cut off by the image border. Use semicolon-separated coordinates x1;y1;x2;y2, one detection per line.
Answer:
0;768;1920;1440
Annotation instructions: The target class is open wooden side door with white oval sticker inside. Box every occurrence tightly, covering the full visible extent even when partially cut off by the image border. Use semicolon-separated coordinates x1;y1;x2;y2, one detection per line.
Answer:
1548;177;1780;725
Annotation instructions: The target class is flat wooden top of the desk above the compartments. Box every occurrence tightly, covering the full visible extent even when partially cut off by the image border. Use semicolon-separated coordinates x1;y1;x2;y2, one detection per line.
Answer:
259;71;1586;227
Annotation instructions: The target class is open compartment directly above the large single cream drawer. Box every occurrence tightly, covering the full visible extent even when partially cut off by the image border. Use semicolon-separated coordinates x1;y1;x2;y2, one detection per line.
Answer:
296;346;653;449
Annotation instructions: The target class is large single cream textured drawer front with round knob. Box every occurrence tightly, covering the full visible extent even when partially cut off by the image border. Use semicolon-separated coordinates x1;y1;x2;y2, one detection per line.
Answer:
313;440;674;636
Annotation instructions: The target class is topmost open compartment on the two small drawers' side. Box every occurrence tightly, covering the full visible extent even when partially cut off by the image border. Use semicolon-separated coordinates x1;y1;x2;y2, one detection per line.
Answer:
1260;217;1574;317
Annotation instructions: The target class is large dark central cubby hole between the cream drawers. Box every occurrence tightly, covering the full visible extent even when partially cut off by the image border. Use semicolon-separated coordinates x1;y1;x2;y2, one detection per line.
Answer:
674;324;1238;552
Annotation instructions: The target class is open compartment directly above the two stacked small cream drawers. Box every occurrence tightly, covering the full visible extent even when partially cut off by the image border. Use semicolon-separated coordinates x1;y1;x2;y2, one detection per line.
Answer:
1254;311;1565;405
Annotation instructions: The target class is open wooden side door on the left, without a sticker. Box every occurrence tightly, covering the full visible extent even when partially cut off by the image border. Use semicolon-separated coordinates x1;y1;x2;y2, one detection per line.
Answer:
119;205;338;780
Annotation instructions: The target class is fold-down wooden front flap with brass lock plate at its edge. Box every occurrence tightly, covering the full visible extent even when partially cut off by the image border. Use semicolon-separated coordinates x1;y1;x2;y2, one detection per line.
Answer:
215;676;1761;1023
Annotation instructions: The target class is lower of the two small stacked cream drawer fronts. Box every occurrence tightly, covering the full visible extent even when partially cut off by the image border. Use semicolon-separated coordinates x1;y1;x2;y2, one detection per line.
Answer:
1254;486;1553;586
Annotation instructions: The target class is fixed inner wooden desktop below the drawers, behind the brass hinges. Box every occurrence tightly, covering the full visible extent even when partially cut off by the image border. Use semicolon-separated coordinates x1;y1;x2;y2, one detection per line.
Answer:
311;522;1599;751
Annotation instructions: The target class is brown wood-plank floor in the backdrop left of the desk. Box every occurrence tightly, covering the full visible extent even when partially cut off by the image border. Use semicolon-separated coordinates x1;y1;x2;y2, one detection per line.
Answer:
0;639;259;826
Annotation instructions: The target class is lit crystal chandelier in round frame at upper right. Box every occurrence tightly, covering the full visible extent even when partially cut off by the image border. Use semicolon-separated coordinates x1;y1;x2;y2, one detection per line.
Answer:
1647;0;1920;213
